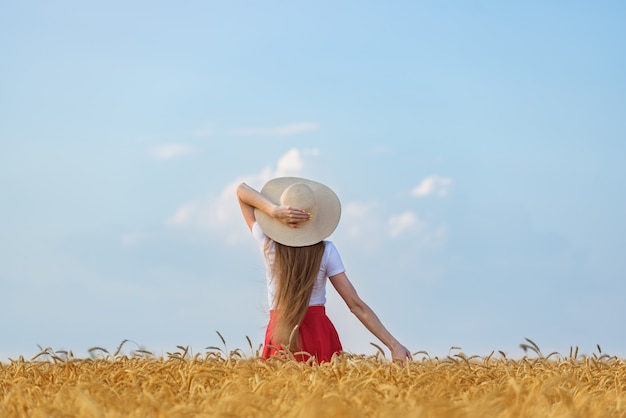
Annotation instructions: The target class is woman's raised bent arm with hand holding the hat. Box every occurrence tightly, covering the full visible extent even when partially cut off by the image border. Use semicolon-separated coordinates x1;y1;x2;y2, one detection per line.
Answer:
237;183;311;229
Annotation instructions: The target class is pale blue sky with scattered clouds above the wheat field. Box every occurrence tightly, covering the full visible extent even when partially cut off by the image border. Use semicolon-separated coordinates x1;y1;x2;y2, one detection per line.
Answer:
0;1;626;359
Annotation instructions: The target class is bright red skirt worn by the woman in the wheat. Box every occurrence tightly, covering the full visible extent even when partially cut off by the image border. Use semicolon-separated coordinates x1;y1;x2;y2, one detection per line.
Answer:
263;306;342;363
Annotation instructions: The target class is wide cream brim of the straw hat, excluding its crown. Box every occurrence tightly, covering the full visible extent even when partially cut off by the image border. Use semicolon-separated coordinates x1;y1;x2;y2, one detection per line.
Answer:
255;177;341;247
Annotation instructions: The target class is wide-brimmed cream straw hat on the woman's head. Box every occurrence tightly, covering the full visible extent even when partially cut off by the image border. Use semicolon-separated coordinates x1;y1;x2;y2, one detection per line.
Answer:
255;177;341;247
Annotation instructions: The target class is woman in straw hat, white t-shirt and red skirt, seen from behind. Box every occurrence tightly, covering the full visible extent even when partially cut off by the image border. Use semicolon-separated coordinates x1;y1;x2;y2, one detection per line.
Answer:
237;177;411;362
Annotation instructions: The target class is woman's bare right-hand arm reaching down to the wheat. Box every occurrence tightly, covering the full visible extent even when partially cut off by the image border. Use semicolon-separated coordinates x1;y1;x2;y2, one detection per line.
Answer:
330;273;412;363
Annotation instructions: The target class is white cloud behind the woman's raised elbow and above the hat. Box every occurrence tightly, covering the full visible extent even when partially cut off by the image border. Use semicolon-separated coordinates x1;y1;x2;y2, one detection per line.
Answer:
167;148;319;245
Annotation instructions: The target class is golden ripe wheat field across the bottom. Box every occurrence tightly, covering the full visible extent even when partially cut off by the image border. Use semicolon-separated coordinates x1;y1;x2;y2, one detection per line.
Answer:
0;340;626;418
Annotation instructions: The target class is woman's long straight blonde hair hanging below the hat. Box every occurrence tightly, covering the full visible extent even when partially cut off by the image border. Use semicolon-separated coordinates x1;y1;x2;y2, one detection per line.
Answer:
271;241;326;351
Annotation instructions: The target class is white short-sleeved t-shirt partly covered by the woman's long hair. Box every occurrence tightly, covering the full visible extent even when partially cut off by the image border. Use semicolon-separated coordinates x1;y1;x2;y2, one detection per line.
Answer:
252;222;346;309
